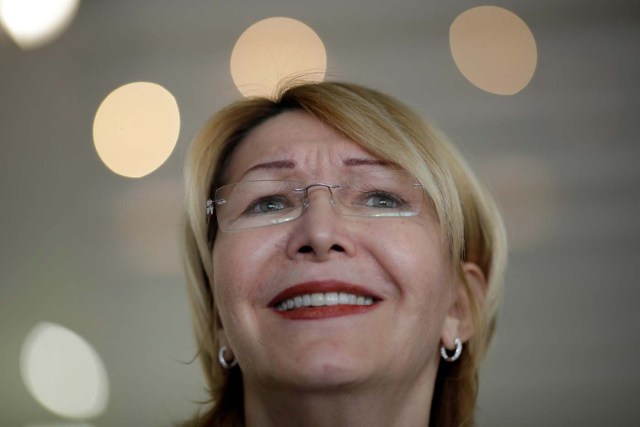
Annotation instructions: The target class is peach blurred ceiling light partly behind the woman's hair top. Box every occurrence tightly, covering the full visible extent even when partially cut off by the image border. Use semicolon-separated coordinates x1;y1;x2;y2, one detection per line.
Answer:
231;17;327;97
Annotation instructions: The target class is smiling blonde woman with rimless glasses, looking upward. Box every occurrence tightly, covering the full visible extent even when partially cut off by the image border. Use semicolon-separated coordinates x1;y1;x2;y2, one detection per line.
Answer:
186;83;506;426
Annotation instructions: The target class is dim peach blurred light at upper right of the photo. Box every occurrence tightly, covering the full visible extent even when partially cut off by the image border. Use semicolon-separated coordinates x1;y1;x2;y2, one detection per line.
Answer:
449;6;538;95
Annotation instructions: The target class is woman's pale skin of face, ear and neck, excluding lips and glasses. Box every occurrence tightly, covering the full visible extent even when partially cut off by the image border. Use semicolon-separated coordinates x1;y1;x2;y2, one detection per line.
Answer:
213;111;484;427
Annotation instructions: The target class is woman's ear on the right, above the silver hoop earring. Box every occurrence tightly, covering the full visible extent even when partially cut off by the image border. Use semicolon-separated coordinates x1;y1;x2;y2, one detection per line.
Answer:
441;262;487;349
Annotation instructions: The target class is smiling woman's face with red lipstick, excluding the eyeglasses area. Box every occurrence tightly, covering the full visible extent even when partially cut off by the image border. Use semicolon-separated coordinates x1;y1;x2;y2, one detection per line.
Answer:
213;111;456;390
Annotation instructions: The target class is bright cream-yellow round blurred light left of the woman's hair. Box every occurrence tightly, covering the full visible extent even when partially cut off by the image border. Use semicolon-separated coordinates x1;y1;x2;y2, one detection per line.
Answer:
93;82;180;178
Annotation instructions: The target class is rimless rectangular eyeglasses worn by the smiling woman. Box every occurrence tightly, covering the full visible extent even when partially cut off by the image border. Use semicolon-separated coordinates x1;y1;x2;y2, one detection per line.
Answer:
206;169;424;231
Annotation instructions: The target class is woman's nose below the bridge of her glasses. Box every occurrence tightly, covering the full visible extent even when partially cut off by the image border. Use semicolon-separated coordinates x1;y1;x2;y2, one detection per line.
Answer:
287;185;356;262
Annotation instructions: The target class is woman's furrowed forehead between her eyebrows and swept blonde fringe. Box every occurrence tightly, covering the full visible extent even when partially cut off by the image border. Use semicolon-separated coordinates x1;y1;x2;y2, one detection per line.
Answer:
227;111;377;182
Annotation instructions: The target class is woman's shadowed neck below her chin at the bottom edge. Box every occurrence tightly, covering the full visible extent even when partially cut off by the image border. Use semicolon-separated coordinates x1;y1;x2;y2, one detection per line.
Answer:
245;373;435;427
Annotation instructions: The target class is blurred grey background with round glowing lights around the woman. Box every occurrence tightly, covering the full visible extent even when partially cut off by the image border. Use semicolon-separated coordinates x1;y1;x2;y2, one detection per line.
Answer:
0;0;640;427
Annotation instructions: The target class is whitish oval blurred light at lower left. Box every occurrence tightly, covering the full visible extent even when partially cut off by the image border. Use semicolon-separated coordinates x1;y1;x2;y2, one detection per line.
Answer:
20;322;109;419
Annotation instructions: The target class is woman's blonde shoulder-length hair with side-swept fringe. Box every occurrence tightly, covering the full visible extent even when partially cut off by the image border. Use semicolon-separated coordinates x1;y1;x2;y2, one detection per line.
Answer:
184;82;507;426
